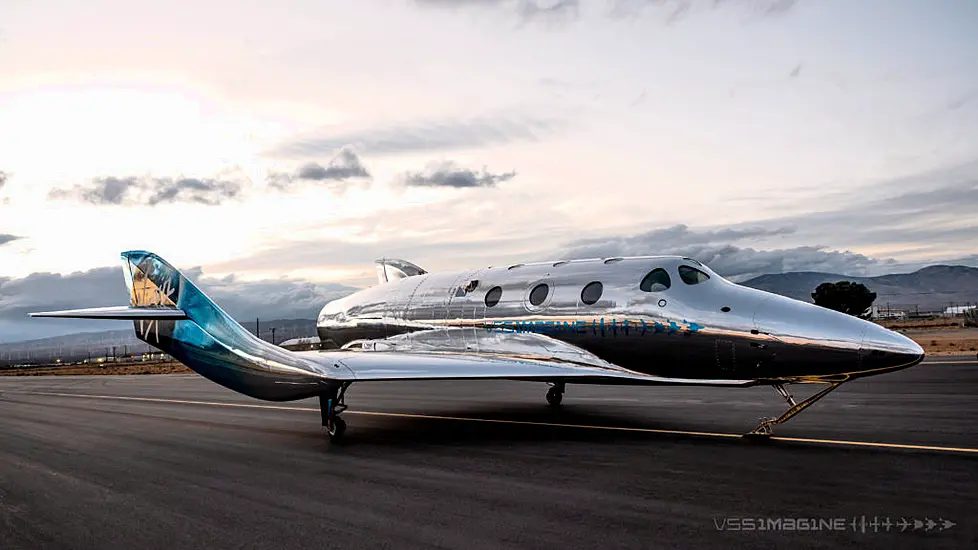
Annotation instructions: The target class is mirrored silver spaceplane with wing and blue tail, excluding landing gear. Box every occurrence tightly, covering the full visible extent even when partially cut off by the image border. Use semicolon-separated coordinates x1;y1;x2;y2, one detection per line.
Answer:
26;251;923;406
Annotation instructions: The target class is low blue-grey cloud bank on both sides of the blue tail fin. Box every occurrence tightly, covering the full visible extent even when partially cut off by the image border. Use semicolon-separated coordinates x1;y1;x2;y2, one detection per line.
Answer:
0;267;356;342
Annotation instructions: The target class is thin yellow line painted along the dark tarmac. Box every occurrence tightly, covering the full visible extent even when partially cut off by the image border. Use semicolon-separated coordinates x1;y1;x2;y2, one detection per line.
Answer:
26;392;978;454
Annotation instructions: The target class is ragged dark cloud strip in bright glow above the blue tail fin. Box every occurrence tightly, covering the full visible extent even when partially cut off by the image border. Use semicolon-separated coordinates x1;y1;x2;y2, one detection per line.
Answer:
49;176;243;206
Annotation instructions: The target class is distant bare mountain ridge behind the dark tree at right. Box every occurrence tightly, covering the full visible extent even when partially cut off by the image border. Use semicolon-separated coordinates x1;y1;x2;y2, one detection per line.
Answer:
740;265;978;311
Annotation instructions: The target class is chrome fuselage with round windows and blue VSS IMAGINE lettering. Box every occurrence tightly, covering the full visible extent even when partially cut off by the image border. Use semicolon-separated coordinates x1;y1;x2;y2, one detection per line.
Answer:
317;256;923;383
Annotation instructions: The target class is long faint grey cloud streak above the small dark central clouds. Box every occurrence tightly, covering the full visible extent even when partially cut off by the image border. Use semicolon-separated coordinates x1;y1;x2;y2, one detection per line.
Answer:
270;116;559;157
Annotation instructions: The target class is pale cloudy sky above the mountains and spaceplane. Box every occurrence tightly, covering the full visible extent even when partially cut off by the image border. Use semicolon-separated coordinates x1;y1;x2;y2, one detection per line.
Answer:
0;0;978;342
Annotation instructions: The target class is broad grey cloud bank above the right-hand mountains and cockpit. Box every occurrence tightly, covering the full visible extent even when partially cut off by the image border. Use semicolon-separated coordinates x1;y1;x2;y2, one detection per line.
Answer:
563;161;978;279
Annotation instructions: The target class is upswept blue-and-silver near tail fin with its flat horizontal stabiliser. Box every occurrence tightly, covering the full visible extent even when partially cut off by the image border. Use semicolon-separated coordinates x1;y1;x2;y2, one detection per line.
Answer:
31;250;327;401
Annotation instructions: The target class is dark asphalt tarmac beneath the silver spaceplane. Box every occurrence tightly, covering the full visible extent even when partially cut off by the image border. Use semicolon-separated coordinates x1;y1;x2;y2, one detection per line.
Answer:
0;359;978;549
